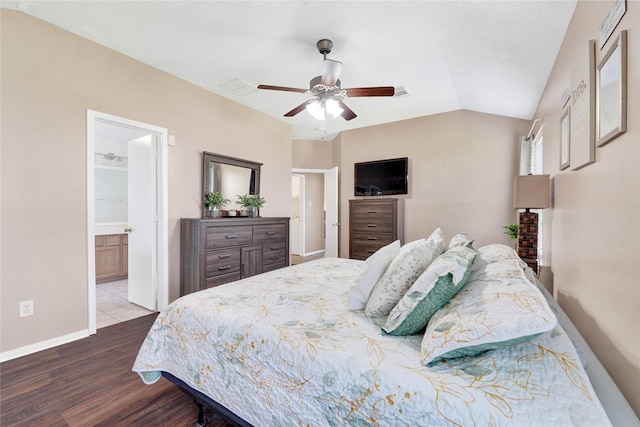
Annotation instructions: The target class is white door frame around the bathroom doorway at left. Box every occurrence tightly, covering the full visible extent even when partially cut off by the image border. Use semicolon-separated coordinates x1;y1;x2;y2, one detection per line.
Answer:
87;109;169;335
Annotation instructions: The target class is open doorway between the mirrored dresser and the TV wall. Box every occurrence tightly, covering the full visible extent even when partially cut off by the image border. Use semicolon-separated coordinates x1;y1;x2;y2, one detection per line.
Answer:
290;167;340;264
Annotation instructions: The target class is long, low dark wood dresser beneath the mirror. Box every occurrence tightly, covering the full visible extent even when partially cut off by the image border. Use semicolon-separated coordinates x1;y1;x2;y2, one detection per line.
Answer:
180;217;289;296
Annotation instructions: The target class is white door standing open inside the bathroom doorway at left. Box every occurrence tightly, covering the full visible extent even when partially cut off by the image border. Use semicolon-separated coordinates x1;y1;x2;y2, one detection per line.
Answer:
127;135;157;310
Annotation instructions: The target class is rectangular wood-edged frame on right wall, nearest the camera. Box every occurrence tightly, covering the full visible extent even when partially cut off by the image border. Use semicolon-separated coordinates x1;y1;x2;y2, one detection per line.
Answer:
596;30;627;147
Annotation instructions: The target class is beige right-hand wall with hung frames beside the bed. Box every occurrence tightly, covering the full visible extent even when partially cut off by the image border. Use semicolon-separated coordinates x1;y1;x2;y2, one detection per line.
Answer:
535;1;640;415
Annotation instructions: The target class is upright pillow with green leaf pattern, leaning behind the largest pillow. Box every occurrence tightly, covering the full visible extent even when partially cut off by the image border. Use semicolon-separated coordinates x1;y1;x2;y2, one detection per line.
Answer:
382;246;476;335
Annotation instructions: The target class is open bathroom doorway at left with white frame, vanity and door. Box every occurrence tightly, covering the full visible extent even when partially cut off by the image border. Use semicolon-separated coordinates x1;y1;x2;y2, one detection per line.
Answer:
87;111;168;333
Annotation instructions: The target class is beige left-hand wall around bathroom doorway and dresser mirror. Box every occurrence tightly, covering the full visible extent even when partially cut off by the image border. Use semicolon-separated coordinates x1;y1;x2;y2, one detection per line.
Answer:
0;9;291;352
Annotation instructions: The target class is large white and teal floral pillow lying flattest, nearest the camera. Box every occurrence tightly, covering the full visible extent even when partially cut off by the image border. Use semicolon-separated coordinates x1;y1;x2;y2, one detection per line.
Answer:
420;260;558;365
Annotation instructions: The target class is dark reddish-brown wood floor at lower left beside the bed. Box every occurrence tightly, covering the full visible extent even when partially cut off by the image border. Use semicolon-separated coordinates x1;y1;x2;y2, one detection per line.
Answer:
0;314;231;427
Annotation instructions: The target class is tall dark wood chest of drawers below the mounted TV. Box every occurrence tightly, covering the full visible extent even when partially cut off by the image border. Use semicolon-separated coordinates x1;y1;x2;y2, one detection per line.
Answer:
349;198;404;260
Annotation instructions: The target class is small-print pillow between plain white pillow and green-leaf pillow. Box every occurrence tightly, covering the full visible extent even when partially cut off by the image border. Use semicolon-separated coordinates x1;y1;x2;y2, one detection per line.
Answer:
365;228;446;317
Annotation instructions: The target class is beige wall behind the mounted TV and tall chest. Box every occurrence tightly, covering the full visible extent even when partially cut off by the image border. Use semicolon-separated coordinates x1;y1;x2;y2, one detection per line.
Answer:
337;110;530;257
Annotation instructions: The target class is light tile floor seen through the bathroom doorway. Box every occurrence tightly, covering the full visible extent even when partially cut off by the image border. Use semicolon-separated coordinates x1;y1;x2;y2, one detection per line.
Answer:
96;279;153;329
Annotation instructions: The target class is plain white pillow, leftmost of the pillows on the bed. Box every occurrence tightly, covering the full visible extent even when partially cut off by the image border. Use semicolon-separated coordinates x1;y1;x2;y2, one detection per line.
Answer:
347;240;400;311
